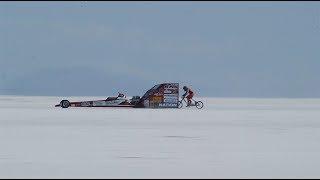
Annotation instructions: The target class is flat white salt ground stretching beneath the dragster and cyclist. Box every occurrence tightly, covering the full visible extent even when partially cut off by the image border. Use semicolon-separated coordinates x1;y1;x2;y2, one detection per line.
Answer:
0;96;320;178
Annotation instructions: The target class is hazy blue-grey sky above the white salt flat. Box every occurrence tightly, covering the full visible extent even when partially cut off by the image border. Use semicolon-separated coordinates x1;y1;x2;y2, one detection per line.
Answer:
0;2;320;97
